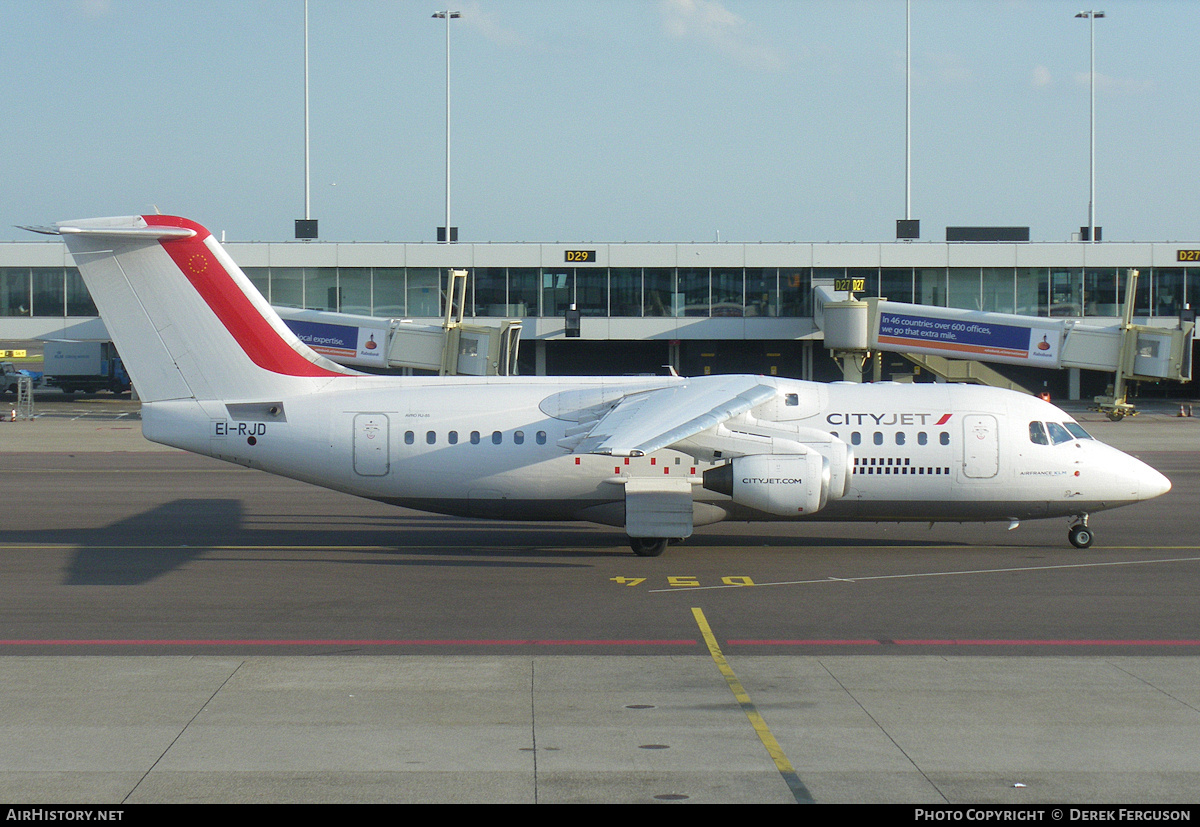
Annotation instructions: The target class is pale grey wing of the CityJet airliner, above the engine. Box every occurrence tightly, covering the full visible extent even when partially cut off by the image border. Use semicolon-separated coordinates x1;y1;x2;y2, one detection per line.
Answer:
574;376;776;456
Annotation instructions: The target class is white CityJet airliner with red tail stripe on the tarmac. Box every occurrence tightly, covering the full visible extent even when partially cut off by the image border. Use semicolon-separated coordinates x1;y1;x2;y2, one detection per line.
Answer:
38;215;1171;557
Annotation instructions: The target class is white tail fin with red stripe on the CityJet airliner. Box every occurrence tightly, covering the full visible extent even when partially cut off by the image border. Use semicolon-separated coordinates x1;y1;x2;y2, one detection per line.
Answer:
54;215;356;402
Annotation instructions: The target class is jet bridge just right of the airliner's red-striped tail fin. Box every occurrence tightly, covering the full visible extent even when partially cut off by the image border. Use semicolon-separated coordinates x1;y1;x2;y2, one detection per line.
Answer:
275;270;522;376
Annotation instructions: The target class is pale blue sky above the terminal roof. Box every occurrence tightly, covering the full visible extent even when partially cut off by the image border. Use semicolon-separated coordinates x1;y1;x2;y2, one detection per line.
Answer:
0;0;1200;241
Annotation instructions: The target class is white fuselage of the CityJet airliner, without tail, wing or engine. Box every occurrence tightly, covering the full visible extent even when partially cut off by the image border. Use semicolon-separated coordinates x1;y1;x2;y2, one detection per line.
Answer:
143;377;1169;525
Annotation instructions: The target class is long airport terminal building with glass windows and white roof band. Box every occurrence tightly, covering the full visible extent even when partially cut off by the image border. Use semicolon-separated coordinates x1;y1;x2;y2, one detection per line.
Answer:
0;240;1200;395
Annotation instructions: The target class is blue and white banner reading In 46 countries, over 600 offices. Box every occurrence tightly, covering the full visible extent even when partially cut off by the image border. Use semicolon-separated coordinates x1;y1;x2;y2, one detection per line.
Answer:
871;301;1063;367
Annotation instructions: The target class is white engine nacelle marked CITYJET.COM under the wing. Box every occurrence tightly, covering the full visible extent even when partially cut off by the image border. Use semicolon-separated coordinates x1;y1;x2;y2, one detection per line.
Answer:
704;451;830;517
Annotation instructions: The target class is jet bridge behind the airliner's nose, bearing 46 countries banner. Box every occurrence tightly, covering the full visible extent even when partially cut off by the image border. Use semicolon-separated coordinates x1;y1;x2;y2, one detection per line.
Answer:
814;270;1195;420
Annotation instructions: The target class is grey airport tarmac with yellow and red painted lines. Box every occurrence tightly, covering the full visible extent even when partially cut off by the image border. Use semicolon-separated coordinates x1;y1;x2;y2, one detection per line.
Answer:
0;400;1200;805
